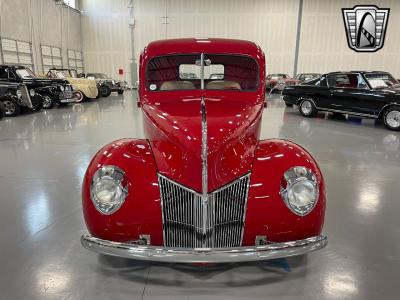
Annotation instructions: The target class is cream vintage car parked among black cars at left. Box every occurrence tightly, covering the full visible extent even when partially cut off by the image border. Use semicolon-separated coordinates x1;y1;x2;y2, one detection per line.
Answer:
46;68;99;102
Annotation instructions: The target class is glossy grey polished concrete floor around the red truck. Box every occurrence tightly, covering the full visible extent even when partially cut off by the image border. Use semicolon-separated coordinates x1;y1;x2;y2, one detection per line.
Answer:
0;92;400;300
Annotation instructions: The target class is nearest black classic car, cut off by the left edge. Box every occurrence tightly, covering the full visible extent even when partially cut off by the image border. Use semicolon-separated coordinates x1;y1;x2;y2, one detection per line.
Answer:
0;82;43;117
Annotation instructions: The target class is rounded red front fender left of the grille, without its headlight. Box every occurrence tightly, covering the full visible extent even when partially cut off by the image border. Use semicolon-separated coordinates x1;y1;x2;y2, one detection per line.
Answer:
82;139;163;245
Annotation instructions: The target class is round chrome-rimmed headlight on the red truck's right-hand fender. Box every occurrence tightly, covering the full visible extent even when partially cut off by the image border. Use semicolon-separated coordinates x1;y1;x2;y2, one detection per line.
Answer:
281;167;319;216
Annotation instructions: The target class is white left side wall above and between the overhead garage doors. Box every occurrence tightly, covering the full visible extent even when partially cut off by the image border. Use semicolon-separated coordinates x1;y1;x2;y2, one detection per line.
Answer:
0;0;82;73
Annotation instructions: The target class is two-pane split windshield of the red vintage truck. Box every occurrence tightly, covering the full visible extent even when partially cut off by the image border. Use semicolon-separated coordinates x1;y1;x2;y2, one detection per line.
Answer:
147;54;259;91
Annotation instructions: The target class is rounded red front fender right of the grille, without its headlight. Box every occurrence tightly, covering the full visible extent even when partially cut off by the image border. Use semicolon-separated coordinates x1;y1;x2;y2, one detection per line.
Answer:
243;139;326;246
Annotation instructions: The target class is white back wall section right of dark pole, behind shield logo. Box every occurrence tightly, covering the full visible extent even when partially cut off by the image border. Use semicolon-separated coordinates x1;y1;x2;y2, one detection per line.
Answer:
298;0;400;78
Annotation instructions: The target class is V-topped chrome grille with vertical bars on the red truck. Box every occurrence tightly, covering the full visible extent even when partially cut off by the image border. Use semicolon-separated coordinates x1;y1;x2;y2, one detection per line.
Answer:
159;174;250;248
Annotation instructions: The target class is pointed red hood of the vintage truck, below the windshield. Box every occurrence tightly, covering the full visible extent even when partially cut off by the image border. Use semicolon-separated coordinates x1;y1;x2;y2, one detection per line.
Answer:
142;91;263;193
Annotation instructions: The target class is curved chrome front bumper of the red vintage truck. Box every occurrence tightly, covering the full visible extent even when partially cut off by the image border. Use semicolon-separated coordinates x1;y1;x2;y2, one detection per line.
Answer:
81;235;328;263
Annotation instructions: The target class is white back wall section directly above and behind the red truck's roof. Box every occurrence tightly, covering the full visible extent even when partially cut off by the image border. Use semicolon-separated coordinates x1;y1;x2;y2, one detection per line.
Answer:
134;0;299;74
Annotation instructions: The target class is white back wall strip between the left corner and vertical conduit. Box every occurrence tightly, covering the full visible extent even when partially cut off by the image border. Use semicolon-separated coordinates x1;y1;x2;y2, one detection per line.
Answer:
81;0;132;83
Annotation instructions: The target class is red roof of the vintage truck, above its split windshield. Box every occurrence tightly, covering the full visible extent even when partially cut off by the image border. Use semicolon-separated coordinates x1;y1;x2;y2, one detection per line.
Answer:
143;38;263;58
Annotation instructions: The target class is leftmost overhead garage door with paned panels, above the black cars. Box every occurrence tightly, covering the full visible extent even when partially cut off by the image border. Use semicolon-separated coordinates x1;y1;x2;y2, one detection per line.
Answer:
1;38;33;70
